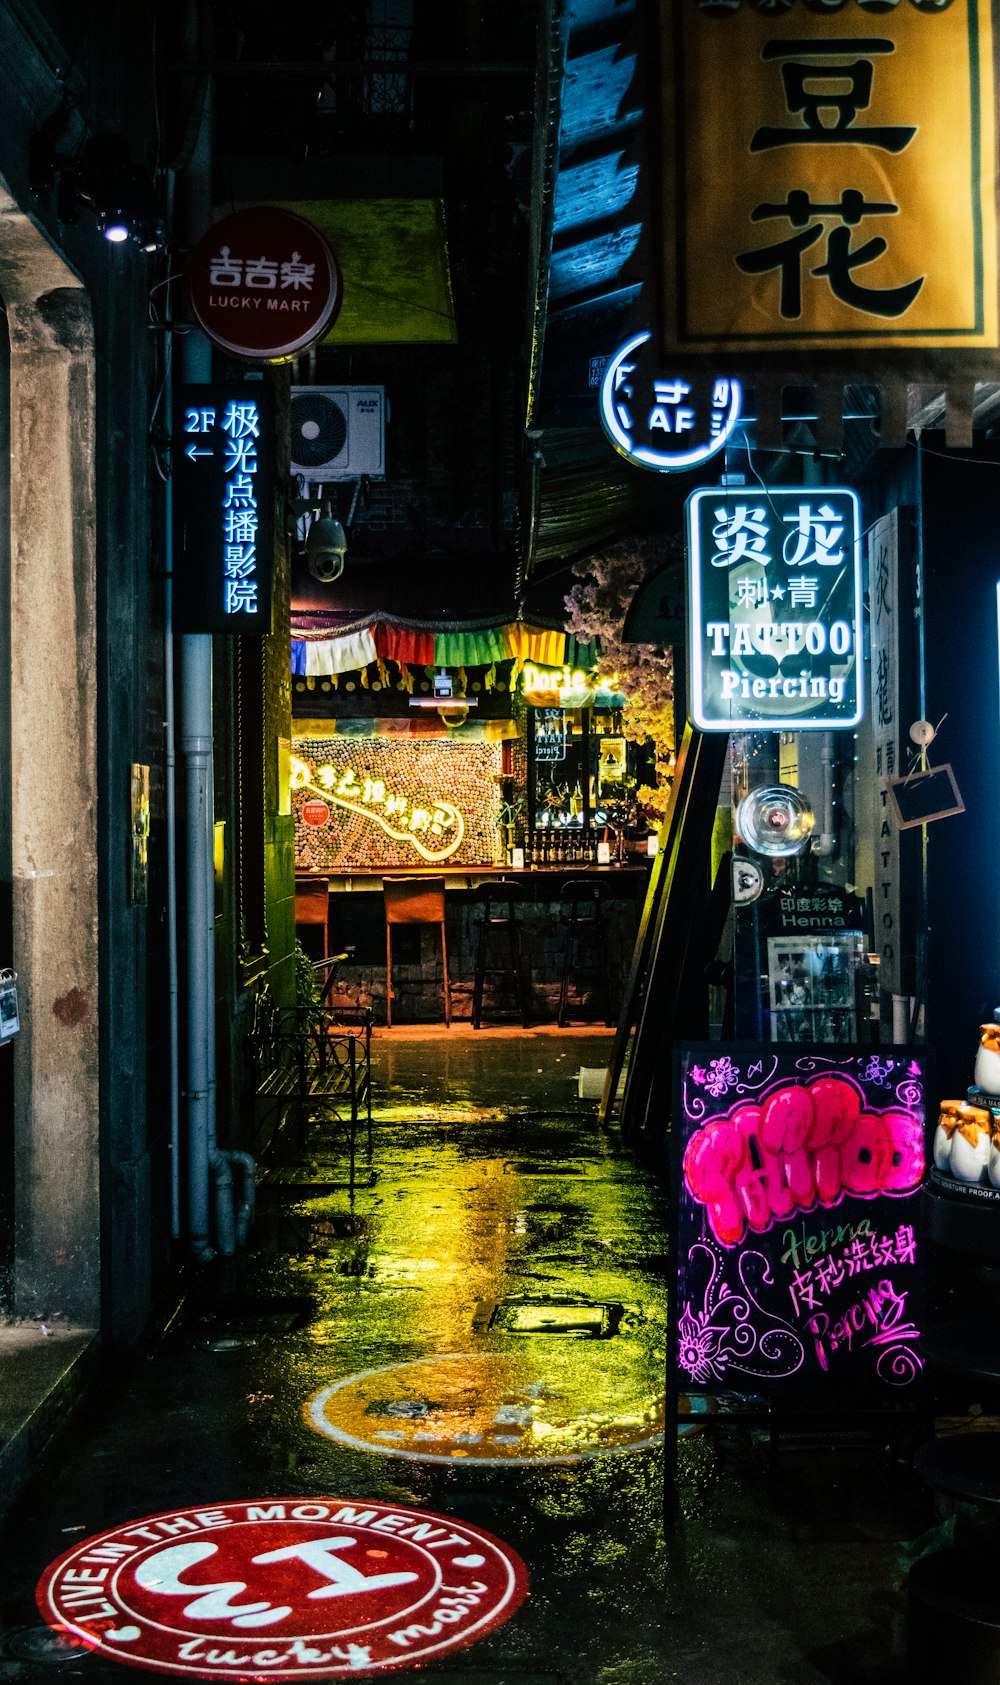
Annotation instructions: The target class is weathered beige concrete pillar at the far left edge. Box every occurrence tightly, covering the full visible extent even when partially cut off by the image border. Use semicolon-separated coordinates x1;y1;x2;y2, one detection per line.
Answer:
7;262;101;1323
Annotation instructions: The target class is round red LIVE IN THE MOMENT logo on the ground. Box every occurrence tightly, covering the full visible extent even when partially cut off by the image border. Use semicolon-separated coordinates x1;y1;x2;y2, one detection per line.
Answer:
37;1498;528;1680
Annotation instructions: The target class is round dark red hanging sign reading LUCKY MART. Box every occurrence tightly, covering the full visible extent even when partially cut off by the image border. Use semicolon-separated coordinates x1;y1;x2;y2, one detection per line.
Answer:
187;206;342;362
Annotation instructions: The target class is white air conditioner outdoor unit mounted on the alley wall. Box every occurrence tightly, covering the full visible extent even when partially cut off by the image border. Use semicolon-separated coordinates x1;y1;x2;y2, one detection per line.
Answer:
292;386;386;484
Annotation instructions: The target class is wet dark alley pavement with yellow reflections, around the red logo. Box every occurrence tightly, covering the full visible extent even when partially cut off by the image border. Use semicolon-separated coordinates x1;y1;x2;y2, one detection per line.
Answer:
0;1028;929;1685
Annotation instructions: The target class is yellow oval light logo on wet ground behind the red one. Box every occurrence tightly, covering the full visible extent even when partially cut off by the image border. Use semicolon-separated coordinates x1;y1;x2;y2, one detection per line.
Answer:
305;1340;664;1464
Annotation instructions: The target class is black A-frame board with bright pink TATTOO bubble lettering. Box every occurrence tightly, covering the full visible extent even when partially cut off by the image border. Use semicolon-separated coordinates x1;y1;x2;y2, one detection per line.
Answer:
668;1041;926;1410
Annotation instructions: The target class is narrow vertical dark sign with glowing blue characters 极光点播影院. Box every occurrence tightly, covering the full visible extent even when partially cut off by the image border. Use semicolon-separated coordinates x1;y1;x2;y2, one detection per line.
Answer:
172;381;275;635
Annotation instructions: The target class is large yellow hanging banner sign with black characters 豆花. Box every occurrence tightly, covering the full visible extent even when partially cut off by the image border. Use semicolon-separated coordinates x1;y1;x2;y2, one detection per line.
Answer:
663;0;998;352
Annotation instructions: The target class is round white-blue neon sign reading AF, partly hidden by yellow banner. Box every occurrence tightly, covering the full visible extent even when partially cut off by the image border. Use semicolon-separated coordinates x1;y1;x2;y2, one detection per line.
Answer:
600;332;742;473
